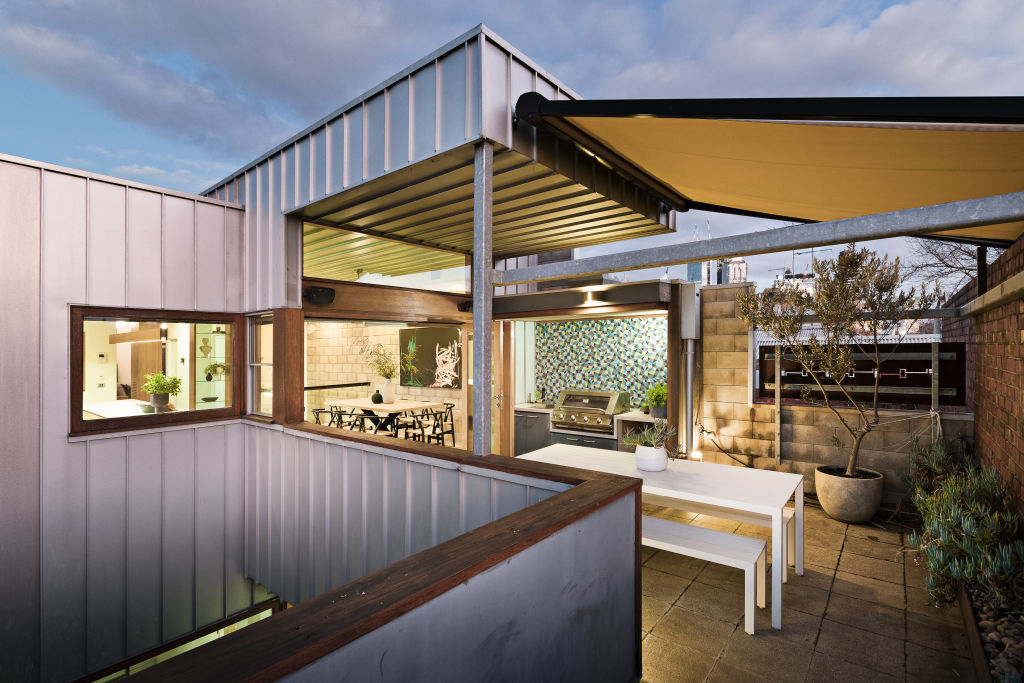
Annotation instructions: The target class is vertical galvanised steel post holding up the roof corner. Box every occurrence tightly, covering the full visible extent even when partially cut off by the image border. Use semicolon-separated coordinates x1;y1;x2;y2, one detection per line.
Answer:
473;140;496;456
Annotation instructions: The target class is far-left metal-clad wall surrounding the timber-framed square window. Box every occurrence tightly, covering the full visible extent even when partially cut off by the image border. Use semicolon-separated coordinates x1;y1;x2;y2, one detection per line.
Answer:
0;156;253;680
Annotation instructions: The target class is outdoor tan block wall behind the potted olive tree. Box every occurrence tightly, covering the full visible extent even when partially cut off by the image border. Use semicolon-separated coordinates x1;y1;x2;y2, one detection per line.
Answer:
697;283;974;502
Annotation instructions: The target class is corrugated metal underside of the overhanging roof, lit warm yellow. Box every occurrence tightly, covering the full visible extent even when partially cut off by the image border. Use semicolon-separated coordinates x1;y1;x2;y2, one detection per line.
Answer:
299;147;670;262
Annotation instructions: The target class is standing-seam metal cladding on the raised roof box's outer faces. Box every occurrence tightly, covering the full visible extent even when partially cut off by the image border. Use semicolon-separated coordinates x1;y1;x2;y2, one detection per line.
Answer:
207;27;575;311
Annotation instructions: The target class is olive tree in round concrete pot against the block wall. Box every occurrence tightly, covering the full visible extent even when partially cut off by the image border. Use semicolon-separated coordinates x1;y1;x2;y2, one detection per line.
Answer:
739;245;938;522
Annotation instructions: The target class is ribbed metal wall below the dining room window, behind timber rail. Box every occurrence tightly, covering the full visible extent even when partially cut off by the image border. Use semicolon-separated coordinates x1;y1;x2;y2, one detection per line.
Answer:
246;424;569;603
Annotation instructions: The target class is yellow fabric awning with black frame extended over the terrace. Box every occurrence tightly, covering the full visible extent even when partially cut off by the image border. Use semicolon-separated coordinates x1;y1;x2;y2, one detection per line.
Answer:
516;93;1024;242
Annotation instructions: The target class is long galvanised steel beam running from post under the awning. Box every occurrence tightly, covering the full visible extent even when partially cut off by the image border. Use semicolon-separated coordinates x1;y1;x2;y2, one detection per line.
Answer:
494;193;1024;286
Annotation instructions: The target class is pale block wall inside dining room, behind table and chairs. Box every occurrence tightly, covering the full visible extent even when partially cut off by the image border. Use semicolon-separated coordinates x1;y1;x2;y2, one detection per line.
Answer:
306;321;468;449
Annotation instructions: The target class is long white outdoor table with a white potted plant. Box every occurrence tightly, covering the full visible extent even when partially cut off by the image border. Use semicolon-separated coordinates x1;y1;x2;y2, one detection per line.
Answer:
519;443;804;629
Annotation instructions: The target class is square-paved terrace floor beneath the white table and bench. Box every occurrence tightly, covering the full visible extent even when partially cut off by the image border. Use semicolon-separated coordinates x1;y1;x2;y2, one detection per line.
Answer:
641;505;975;683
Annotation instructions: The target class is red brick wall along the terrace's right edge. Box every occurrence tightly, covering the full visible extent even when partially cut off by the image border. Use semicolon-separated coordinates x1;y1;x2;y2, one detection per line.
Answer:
942;238;1024;512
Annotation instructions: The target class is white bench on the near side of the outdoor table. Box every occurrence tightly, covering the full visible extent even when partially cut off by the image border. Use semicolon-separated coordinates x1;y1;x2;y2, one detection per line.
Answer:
642;515;767;634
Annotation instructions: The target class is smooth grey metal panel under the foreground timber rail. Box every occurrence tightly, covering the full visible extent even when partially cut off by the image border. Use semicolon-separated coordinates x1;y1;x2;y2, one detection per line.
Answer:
286;496;639;682
